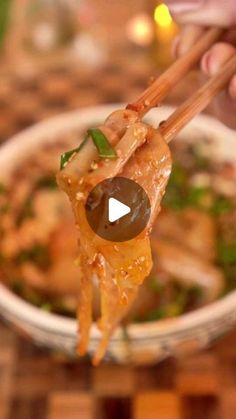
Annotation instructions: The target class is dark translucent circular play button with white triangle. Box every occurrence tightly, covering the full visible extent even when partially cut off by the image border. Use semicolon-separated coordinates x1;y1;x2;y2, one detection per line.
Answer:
85;177;151;242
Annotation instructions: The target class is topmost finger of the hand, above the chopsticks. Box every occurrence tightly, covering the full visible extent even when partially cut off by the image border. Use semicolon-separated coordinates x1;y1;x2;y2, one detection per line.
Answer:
166;0;236;27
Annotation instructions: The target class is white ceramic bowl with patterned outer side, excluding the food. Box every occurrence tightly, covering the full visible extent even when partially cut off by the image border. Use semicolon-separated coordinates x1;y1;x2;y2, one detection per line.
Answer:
0;105;236;363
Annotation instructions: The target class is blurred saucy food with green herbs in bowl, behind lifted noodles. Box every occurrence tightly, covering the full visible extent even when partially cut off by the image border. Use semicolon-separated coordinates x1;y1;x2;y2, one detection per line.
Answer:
1;112;236;364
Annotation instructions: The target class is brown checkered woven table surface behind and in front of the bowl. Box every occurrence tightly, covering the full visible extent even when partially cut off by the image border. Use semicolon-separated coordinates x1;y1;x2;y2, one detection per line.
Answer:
0;60;232;419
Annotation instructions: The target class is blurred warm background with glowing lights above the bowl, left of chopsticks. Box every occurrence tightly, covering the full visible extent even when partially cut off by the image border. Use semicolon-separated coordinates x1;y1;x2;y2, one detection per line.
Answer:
0;0;195;141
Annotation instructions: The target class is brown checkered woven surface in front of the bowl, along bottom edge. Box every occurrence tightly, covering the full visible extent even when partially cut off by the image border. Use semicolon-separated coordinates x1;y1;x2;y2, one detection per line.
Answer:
0;325;236;419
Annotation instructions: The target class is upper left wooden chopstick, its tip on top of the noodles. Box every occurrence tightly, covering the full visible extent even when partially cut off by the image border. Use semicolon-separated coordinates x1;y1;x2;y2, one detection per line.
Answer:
127;28;224;117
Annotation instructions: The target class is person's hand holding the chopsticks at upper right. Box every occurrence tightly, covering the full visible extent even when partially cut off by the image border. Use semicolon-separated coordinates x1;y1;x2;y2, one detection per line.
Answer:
166;0;236;129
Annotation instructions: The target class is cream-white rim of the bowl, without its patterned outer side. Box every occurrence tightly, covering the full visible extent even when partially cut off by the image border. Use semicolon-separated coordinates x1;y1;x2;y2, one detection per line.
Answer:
0;104;236;342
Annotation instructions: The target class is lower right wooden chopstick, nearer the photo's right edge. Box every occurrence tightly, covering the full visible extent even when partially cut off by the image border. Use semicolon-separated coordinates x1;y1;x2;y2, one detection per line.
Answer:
159;54;236;143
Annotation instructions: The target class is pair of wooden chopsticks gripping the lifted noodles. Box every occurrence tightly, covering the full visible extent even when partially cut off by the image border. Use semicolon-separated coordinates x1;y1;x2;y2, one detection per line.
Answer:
127;28;236;142
